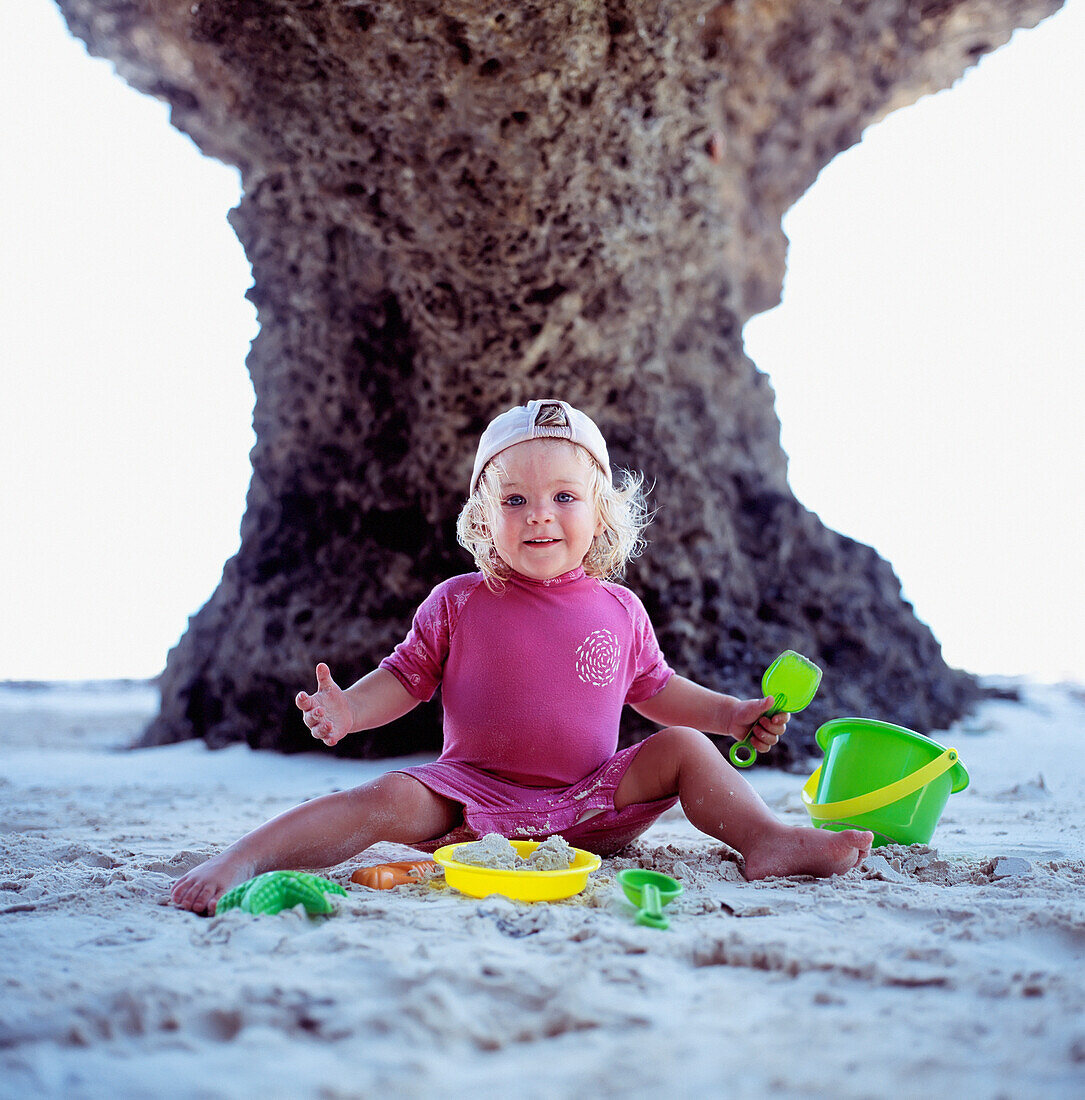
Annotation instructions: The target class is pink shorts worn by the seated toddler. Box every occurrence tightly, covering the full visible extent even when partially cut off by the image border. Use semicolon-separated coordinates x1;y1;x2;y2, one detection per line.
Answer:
389;741;678;856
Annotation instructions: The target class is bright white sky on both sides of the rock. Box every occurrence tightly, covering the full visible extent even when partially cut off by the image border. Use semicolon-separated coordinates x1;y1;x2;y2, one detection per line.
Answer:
6;0;1085;681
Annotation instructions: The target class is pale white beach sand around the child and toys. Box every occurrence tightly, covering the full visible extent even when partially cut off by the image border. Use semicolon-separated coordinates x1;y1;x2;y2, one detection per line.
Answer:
0;686;1085;1100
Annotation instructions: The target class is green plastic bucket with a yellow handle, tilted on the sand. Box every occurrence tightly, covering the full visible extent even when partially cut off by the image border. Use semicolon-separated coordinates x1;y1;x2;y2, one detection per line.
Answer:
802;718;968;848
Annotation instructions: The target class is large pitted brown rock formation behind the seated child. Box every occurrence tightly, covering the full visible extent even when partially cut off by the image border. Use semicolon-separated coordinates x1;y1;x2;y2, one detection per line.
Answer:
61;0;1057;752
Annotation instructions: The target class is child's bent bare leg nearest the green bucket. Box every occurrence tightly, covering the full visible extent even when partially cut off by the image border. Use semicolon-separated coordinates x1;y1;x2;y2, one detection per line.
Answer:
614;726;874;879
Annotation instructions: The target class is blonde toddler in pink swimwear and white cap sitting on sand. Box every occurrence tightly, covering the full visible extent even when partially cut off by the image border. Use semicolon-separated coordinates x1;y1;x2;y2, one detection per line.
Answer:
173;400;873;913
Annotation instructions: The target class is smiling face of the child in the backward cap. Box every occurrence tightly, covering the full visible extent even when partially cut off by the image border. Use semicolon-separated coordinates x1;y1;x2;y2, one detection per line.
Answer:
491;439;603;581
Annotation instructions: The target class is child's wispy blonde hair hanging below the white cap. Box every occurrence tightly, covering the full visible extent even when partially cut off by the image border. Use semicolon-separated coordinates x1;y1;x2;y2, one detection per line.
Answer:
456;439;651;589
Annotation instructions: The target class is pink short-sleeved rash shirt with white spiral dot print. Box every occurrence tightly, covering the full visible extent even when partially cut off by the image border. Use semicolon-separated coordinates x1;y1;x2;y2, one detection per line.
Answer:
381;569;673;788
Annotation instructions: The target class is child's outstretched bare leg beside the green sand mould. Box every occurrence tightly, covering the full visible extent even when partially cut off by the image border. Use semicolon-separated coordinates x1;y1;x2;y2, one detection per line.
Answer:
171;772;462;913
